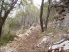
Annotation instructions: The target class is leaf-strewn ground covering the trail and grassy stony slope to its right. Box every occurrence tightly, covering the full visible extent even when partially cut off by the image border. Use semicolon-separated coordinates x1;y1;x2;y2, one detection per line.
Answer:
0;23;68;52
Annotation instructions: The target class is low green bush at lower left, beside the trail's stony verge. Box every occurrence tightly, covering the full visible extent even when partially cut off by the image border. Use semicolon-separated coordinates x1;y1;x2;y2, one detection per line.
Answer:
0;33;16;46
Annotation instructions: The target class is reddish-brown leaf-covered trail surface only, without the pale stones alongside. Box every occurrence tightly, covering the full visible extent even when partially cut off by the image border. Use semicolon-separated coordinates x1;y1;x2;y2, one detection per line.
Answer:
17;27;41;52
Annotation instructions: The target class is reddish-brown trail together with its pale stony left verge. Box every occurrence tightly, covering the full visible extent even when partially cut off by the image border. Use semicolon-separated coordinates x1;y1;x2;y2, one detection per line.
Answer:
0;26;43;52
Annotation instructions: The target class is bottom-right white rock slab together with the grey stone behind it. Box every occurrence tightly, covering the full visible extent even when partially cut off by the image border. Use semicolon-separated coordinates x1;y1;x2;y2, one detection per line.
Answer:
48;34;69;52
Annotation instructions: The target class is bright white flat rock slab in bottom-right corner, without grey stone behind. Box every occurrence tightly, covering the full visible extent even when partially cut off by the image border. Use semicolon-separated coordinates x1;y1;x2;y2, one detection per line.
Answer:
48;40;69;52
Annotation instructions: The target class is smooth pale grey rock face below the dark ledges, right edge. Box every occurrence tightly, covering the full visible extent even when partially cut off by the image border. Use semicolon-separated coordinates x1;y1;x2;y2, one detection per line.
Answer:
57;13;69;30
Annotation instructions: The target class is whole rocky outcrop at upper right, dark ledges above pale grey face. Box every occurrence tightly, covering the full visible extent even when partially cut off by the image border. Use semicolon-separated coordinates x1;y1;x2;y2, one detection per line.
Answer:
53;0;69;30
